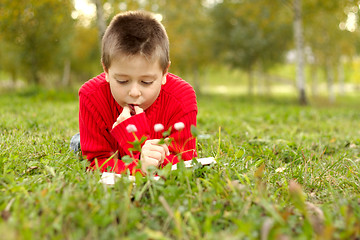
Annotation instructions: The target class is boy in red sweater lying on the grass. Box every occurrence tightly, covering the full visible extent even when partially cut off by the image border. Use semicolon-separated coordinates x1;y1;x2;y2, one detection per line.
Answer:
79;11;197;174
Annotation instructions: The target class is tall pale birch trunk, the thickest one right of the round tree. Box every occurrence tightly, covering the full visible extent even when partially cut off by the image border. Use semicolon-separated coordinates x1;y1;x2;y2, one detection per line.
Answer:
294;0;307;105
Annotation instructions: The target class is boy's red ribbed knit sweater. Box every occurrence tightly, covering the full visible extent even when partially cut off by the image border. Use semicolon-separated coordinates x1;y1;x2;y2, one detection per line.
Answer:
79;73;197;174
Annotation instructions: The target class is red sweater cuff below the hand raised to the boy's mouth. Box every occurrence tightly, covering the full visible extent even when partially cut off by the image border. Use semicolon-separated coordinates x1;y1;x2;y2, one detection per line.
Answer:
110;113;150;156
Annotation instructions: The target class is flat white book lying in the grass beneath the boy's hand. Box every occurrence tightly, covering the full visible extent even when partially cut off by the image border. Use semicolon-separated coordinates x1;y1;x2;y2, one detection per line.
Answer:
99;157;216;185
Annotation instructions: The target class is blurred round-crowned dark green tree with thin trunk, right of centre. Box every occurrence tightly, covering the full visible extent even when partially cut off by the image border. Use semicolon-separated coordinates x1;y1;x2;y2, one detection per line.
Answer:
211;0;292;94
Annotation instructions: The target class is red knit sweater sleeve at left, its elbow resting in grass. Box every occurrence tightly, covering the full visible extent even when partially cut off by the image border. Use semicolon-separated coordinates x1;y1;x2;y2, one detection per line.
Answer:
79;94;140;173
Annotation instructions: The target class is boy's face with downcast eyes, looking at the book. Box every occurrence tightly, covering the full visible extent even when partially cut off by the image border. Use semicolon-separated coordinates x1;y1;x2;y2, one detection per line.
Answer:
104;55;167;110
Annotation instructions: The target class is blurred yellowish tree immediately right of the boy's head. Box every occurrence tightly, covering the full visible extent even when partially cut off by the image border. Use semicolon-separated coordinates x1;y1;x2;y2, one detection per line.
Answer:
159;0;214;94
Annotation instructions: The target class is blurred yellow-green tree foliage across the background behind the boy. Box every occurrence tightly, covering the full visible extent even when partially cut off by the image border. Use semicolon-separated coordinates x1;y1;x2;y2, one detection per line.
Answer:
0;0;359;98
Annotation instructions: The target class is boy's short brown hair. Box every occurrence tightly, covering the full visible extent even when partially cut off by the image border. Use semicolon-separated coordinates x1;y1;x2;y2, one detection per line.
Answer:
101;11;170;72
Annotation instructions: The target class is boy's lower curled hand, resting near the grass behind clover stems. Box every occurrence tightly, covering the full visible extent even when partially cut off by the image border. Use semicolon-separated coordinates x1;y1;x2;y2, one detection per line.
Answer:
140;139;170;173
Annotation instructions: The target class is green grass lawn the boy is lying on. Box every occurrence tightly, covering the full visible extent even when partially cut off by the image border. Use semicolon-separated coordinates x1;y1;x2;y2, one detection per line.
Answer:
0;90;360;239
